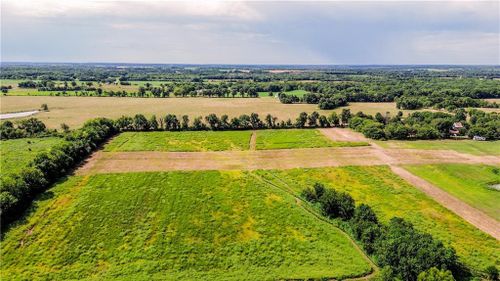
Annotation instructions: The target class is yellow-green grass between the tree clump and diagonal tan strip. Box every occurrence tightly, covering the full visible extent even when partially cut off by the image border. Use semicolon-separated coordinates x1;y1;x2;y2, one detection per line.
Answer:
257;166;500;270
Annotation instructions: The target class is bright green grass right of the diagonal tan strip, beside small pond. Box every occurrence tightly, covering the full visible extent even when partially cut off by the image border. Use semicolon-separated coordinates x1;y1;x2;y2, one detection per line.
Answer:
406;164;500;221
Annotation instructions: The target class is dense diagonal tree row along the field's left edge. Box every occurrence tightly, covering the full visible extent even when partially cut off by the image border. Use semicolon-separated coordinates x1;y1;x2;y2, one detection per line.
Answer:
0;118;116;225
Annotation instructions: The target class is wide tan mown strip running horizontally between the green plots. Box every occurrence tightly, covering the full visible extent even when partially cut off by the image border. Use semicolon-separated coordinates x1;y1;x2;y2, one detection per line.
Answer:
77;145;500;174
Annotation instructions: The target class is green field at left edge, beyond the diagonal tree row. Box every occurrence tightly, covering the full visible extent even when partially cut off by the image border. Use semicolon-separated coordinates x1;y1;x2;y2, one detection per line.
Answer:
0;137;64;175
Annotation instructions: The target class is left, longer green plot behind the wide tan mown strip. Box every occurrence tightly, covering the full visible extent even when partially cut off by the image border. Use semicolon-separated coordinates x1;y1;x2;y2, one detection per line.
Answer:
104;131;252;151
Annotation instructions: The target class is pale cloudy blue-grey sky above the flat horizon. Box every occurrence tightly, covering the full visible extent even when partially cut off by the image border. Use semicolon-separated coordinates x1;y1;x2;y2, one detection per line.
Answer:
0;0;500;65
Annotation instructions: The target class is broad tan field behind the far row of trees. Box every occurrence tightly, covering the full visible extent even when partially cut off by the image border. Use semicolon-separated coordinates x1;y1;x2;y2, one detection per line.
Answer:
0;96;426;128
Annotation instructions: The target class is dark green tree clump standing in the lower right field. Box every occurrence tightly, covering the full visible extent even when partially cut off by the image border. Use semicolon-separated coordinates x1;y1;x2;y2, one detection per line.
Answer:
301;183;472;281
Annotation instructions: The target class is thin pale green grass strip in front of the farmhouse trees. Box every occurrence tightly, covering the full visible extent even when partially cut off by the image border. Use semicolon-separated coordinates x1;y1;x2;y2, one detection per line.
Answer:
377;140;500;155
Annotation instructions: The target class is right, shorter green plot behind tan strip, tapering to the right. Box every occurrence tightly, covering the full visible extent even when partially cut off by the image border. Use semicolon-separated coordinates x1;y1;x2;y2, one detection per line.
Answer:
256;129;368;150
